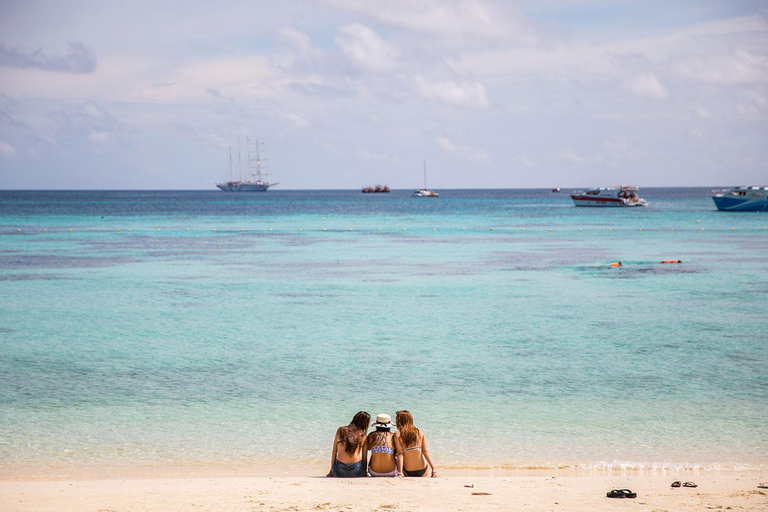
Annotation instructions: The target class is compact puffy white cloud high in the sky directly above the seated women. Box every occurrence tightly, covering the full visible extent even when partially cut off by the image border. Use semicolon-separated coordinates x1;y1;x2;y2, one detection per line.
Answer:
334;23;400;72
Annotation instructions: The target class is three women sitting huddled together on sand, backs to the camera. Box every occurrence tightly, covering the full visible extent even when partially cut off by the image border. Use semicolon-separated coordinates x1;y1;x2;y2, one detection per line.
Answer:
328;411;437;478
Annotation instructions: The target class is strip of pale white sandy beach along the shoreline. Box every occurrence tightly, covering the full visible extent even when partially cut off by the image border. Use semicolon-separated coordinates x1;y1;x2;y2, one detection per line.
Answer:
0;472;768;512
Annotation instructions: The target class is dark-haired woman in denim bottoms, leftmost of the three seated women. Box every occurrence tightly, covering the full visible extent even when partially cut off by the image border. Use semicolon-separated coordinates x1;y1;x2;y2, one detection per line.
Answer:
327;411;371;478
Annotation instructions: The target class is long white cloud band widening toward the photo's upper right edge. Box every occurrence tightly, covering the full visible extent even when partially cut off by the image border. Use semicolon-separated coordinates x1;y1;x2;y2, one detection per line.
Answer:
447;10;768;85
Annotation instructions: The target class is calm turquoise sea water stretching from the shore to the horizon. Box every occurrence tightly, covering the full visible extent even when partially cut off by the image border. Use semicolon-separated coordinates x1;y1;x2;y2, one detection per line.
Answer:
0;188;768;476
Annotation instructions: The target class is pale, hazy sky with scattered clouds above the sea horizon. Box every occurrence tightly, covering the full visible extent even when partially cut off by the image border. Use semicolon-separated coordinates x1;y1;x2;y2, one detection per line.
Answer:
0;0;768;190
